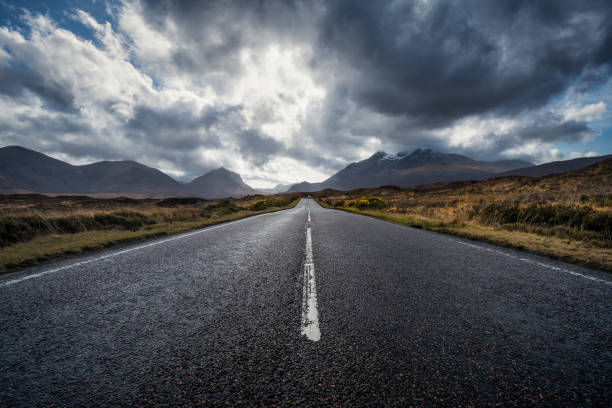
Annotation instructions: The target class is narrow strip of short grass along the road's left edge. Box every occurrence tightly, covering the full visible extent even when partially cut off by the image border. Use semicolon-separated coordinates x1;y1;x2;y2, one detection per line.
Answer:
0;200;299;273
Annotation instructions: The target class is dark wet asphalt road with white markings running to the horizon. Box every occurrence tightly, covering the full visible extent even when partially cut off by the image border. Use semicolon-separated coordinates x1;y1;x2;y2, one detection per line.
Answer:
0;199;612;407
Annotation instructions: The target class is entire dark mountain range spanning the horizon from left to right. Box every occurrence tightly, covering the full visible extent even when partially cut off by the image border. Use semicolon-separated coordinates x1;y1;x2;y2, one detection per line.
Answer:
0;146;612;199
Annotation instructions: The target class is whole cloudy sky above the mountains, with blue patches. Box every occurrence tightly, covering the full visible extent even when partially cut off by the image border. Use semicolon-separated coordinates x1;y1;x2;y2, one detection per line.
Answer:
0;0;612;188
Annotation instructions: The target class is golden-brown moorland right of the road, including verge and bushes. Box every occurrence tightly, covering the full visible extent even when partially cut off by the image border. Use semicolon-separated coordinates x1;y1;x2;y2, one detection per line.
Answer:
314;160;612;271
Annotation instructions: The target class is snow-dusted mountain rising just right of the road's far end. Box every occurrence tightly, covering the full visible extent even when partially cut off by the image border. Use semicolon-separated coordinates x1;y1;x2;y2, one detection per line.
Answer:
289;149;532;192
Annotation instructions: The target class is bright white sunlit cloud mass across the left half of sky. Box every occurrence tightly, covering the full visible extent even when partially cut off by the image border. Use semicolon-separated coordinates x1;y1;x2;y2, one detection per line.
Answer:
0;3;325;185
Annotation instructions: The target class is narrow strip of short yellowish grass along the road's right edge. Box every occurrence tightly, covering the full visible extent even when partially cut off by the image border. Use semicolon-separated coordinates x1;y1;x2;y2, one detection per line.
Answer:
317;199;612;272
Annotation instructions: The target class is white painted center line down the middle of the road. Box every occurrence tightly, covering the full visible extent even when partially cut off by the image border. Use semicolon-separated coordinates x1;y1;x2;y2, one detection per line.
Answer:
300;204;321;341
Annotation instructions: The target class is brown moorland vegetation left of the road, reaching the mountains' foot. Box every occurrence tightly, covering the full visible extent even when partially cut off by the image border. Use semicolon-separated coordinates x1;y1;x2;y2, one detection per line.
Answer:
0;194;299;272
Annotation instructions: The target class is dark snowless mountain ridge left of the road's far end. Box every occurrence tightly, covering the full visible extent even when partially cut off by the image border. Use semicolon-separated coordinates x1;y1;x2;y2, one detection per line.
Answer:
0;146;256;198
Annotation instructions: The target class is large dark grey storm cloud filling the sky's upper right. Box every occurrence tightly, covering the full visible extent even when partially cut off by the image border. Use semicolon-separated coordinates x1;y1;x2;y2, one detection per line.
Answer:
319;0;612;127
